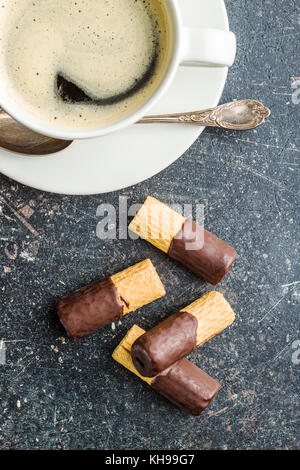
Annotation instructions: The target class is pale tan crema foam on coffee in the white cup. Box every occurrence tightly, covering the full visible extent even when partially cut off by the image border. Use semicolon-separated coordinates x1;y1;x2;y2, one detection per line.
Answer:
0;0;169;128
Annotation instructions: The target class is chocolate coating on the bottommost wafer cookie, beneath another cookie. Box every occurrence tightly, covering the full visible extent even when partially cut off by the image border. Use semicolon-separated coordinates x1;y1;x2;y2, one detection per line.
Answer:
151;359;220;416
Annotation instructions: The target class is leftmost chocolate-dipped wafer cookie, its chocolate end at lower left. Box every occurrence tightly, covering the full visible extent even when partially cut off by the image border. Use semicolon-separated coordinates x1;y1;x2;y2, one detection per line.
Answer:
57;259;166;339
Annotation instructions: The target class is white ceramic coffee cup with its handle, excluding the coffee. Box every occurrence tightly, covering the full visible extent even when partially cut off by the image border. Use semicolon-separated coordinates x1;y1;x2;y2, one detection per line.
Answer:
0;0;236;140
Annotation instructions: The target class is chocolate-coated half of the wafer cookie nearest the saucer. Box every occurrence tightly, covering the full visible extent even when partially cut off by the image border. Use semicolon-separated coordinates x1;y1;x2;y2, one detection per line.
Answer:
168;219;237;285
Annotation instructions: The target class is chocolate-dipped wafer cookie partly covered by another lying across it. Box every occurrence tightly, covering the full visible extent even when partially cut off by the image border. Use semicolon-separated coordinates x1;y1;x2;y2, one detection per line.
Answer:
113;325;220;415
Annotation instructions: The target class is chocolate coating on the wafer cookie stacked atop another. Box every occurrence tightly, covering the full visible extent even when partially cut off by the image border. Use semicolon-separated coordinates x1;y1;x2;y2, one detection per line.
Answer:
131;312;198;377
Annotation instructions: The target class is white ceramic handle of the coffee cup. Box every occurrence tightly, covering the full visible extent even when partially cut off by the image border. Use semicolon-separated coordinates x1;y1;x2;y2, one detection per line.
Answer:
181;28;236;67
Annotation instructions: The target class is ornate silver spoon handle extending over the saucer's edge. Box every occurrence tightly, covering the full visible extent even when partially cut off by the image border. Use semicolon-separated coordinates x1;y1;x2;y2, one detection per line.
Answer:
139;100;270;130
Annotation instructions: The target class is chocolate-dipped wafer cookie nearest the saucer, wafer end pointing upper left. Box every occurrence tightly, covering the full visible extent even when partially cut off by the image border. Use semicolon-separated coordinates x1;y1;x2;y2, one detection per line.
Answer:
129;197;237;285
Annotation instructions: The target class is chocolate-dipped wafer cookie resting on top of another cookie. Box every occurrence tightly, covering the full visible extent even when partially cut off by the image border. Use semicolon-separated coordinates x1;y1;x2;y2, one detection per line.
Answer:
131;292;235;377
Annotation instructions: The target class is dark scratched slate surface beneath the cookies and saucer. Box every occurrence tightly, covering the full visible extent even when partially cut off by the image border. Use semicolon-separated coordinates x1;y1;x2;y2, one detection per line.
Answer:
0;0;300;449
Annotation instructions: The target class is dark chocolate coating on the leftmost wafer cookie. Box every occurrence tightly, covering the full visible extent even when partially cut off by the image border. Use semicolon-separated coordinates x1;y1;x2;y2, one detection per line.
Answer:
57;278;123;339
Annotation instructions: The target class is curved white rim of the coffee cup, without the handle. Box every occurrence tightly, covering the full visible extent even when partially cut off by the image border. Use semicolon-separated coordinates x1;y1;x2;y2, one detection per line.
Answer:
0;0;182;140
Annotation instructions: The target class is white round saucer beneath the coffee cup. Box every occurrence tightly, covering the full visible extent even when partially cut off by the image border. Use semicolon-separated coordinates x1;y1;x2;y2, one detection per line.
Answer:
0;0;229;195
